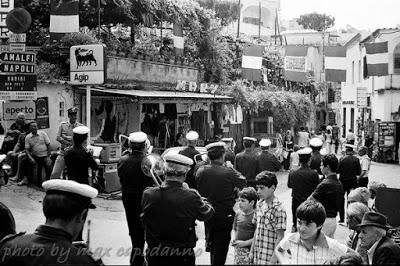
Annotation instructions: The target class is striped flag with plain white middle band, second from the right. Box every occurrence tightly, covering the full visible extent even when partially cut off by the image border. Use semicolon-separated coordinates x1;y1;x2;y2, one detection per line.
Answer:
324;46;347;82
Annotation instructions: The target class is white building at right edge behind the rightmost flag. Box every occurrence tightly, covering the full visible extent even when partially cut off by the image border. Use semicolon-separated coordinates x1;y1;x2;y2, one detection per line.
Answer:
341;29;400;141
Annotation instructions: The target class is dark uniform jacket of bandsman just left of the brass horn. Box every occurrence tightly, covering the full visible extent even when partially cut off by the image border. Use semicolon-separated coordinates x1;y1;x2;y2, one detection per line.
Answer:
118;151;154;195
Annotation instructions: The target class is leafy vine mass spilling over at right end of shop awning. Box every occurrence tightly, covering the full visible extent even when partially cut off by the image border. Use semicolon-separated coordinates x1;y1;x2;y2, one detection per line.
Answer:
221;80;313;130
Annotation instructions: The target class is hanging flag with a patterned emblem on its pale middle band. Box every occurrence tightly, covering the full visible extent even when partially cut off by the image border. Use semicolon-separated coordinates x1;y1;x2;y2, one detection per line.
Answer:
284;45;308;82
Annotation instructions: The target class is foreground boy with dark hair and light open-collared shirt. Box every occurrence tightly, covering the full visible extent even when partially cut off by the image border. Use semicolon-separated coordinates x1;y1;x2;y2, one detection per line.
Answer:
275;200;349;265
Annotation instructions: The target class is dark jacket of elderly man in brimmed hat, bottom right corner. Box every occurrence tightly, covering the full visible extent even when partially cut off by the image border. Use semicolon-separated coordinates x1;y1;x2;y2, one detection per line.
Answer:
372;237;400;265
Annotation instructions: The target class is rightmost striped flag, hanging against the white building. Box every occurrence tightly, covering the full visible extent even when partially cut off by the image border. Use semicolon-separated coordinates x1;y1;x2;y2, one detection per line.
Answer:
365;42;389;77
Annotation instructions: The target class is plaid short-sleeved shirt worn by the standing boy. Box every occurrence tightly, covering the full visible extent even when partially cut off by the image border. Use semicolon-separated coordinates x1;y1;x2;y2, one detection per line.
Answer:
252;197;286;265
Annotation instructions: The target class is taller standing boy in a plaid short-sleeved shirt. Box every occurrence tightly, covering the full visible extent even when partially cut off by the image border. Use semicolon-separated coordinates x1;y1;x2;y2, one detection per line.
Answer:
250;171;286;265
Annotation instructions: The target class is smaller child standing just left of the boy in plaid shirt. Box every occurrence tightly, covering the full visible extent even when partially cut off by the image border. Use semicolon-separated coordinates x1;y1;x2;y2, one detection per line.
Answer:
232;187;258;265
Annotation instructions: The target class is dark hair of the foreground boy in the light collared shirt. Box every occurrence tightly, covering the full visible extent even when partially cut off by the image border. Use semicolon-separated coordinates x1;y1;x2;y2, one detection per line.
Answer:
296;200;326;226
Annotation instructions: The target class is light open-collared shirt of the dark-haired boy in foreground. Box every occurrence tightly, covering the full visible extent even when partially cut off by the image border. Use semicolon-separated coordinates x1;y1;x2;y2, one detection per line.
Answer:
278;232;348;265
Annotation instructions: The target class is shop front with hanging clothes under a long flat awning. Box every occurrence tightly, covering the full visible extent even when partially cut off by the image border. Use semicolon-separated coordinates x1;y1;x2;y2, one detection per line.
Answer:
76;87;232;151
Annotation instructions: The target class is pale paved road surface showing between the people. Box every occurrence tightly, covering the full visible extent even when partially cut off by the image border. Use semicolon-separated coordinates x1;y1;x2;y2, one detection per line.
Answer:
0;162;400;265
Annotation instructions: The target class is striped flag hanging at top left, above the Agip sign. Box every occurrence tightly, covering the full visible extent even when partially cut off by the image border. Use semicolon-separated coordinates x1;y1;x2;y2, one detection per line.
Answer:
50;0;79;33
